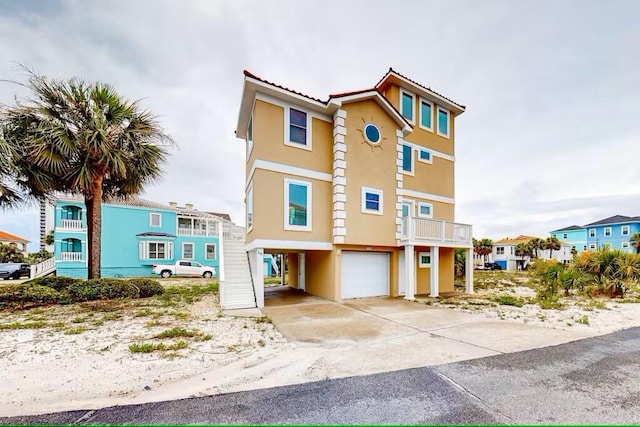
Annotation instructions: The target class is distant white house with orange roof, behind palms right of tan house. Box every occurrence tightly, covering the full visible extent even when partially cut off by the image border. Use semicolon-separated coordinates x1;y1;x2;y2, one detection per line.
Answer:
491;235;573;271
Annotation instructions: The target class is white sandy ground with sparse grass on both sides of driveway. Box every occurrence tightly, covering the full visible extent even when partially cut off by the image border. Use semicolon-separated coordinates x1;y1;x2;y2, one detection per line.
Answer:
0;279;640;416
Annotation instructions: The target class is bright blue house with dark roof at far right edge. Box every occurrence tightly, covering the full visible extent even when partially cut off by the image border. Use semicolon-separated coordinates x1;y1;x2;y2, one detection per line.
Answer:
584;215;640;252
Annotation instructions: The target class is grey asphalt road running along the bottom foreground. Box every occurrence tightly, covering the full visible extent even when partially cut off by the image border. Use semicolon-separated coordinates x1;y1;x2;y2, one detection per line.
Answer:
0;328;640;424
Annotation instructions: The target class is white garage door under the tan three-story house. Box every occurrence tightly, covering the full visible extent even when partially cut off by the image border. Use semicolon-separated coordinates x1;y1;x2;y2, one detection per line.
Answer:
342;251;389;298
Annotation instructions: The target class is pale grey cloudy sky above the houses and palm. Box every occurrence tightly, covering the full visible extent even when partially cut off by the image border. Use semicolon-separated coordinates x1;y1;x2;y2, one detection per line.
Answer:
0;0;640;249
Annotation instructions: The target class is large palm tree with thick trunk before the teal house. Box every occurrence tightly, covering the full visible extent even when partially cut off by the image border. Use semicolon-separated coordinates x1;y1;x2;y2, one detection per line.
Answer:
0;72;173;278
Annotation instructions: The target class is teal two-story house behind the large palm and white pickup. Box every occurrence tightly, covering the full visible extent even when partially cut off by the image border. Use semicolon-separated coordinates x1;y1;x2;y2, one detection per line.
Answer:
40;196;231;278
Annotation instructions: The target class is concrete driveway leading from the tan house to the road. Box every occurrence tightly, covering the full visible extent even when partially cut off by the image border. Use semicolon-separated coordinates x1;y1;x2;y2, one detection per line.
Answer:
263;289;595;377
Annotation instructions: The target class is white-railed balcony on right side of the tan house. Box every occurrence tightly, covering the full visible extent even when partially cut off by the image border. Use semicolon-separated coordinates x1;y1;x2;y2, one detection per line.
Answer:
400;217;471;247
